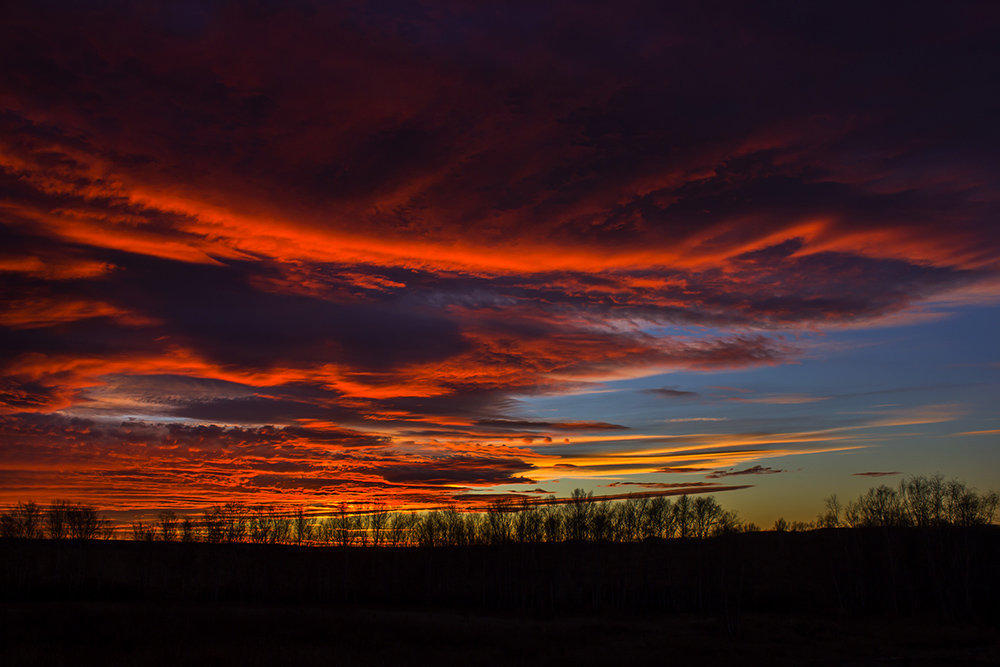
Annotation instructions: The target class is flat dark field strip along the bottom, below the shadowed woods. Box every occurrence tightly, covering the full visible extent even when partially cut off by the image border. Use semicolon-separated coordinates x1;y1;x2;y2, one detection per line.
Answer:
0;602;1000;667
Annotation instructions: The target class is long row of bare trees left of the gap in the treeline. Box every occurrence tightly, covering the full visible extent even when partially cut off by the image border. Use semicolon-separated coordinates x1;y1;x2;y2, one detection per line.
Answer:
0;489;744;547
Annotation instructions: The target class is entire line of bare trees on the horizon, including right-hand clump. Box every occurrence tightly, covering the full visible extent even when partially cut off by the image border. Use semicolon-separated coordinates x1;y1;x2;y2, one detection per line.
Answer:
0;474;1000;547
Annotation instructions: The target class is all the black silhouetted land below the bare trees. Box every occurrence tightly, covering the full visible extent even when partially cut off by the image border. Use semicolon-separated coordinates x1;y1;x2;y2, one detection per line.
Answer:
0;528;1000;665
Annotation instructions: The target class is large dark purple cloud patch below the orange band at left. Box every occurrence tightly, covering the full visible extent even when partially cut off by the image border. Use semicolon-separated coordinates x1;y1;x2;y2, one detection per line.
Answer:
101;253;466;370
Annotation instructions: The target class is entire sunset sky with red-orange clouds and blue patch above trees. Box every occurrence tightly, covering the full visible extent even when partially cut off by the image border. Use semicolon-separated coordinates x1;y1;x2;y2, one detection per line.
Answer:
0;0;1000;525
